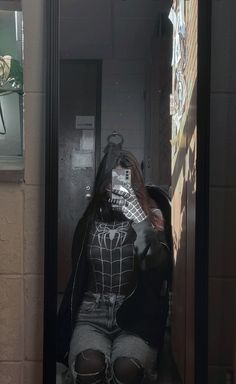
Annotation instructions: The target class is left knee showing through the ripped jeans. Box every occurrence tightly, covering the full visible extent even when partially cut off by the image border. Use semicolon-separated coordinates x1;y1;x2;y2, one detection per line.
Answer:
74;349;106;384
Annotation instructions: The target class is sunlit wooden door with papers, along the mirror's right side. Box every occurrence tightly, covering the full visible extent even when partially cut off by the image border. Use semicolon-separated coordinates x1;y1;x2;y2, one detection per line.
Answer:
170;0;198;384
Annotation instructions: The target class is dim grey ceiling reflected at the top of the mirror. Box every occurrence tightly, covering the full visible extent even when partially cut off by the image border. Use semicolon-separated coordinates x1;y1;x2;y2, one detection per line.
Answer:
60;0;171;60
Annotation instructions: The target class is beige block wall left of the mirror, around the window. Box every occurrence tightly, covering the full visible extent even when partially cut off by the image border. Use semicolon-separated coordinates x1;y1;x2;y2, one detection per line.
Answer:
0;0;45;384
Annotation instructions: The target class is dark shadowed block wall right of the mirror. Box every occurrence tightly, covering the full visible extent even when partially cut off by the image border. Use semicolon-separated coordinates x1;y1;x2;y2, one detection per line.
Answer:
209;0;236;384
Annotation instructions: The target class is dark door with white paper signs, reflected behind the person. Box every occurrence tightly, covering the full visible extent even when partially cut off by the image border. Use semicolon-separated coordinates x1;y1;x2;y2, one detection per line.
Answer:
58;60;101;292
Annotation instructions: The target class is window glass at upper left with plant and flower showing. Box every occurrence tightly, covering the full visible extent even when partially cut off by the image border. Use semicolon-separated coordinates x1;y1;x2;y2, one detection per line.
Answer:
0;10;23;158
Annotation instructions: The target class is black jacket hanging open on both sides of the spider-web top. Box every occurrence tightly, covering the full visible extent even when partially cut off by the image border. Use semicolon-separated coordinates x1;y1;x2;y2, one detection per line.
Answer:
57;214;171;363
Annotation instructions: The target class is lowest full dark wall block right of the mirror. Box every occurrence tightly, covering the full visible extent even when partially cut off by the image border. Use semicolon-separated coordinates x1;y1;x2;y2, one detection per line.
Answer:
208;278;236;366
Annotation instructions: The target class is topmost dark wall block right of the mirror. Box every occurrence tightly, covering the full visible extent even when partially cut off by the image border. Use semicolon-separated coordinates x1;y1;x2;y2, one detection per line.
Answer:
211;0;236;92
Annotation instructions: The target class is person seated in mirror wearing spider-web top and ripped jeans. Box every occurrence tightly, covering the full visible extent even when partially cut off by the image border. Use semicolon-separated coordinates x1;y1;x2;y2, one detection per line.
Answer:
57;143;171;384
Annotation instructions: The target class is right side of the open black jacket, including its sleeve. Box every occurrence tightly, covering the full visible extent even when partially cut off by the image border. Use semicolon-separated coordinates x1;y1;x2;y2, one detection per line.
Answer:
117;218;172;349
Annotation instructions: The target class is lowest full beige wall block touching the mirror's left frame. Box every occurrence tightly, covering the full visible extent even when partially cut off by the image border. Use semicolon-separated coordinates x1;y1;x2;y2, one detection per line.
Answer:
24;276;43;360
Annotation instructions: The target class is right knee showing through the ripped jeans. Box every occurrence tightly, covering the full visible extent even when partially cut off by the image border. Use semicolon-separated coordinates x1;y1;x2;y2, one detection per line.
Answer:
113;357;143;384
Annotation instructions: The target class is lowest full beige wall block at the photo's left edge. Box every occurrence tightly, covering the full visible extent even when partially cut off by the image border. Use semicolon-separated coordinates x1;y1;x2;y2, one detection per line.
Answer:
0;275;24;361
